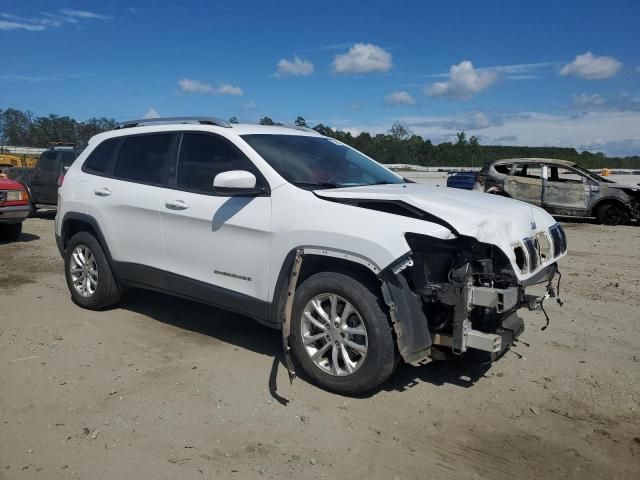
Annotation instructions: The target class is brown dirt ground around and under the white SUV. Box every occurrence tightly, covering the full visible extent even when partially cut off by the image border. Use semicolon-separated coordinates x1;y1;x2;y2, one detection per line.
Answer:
0;213;640;480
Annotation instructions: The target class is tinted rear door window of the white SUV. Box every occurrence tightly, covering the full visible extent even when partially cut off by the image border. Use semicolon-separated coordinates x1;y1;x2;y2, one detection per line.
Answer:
113;133;173;185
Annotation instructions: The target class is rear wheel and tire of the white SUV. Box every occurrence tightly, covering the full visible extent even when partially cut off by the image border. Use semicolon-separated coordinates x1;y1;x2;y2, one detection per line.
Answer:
64;232;122;310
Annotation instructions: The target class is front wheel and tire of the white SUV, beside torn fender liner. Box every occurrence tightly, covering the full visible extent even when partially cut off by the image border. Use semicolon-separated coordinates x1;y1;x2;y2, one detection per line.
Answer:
291;272;397;395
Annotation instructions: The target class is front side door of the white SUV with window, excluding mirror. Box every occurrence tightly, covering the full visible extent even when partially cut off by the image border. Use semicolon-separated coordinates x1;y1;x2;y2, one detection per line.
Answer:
160;132;271;316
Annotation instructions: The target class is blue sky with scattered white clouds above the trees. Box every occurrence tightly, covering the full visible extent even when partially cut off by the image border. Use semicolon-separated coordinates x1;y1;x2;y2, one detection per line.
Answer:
0;0;640;154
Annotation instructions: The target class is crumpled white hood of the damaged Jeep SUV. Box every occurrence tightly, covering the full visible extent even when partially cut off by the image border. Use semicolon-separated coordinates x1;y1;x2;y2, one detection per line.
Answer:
314;183;556;246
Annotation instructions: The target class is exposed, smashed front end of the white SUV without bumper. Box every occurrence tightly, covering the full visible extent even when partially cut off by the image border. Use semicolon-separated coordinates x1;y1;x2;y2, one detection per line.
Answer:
380;232;566;363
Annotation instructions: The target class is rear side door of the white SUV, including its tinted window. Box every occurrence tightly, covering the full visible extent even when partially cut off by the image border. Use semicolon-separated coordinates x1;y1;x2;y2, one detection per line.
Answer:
82;133;176;288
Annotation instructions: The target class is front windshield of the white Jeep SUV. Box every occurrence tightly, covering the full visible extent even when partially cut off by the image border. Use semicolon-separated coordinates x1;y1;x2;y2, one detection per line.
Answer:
242;135;404;188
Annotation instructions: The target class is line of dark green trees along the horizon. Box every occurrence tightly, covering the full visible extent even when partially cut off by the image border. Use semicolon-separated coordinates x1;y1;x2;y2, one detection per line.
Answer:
0;108;640;168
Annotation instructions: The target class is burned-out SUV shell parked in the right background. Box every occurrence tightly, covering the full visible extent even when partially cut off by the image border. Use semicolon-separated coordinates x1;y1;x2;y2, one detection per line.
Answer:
478;158;640;225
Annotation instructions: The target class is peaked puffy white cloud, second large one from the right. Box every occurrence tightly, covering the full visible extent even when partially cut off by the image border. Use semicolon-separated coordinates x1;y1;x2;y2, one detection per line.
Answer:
425;60;498;100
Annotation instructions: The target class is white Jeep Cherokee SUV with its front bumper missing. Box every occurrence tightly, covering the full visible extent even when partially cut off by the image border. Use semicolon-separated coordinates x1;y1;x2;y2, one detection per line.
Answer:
55;117;567;394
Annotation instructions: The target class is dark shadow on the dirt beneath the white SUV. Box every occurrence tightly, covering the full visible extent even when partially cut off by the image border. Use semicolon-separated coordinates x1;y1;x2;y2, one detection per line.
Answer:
121;290;490;405
